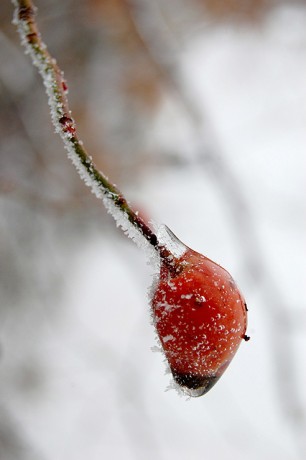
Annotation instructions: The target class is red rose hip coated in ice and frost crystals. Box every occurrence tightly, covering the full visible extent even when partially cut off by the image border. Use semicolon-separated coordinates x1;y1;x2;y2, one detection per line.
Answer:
152;243;247;396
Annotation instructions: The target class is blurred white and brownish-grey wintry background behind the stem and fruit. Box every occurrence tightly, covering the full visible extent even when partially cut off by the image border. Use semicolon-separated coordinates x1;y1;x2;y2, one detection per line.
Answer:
0;0;306;460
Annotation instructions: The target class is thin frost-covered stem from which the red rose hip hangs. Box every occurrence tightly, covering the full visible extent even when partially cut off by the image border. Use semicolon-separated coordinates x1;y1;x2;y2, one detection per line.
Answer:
12;0;165;258
